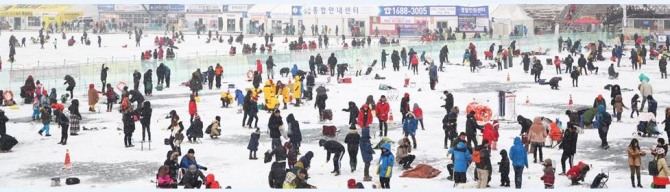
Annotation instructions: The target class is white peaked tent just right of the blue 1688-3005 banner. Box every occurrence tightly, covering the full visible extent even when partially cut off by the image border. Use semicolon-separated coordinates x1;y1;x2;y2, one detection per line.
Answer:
490;4;535;36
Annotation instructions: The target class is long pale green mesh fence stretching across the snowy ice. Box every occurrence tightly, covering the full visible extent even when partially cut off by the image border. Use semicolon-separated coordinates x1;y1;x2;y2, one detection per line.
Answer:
2;33;618;97
